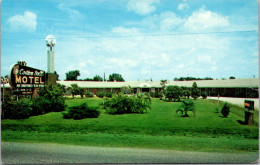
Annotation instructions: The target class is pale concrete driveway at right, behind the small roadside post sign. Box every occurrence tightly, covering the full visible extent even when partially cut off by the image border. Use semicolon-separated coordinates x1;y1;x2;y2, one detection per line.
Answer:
208;97;259;110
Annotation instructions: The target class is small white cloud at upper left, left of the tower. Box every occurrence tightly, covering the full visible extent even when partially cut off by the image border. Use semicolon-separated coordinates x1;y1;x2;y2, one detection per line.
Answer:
7;11;37;32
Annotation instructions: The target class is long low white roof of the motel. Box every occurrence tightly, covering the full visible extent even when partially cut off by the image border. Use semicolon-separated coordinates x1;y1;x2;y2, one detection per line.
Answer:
1;79;259;88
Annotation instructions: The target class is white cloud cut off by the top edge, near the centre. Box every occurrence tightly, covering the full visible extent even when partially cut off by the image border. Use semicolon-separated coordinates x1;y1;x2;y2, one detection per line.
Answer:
127;0;160;15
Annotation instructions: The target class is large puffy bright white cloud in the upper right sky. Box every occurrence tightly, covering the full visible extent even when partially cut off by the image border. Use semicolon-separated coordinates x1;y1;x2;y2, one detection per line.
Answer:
184;8;229;31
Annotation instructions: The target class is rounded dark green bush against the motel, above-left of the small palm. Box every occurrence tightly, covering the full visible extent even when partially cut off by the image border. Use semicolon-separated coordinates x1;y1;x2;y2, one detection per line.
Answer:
165;85;182;101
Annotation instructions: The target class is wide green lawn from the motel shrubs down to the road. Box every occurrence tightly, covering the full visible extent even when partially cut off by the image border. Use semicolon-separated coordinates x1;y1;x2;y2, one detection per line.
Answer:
2;98;258;152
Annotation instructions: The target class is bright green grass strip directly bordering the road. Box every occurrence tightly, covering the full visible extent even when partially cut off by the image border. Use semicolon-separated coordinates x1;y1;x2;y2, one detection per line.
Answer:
2;131;258;153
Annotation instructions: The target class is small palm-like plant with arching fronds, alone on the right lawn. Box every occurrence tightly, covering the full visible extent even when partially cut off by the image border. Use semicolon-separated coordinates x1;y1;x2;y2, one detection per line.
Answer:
176;99;195;117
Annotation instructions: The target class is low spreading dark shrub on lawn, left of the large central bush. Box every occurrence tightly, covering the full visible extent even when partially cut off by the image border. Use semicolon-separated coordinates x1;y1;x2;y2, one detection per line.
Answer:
62;103;100;120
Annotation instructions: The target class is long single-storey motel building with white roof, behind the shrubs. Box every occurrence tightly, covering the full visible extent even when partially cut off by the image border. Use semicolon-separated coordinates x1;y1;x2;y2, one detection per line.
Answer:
1;78;259;98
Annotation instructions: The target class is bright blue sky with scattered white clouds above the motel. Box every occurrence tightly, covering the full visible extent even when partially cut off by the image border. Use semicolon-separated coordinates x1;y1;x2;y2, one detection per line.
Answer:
1;0;259;81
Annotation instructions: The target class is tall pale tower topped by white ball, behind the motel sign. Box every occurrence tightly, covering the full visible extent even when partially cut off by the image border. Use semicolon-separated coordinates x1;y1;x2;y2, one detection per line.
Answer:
45;35;57;85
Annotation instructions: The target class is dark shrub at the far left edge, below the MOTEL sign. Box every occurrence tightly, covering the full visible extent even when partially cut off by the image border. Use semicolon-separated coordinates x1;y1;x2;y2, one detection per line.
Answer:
2;99;32;119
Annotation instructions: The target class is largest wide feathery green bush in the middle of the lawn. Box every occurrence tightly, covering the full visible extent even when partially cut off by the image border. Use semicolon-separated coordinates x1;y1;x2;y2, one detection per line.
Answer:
104;94;151;115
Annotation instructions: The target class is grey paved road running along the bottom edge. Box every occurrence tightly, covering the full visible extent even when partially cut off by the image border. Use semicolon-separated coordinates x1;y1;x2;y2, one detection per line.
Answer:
2;142;258;164
